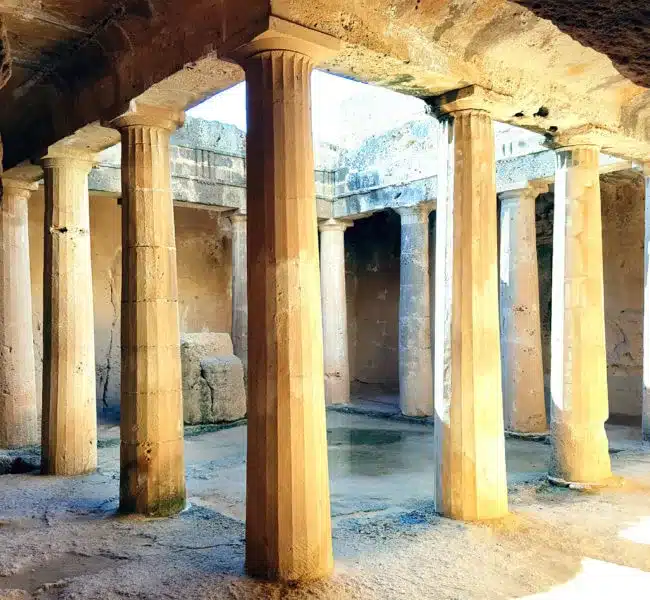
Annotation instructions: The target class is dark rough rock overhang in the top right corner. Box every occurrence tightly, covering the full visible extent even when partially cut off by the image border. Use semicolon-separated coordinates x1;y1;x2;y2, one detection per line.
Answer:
515;0;650;87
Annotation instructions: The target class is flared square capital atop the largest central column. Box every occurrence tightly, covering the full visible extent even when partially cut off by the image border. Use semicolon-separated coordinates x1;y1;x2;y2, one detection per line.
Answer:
219;14;341;64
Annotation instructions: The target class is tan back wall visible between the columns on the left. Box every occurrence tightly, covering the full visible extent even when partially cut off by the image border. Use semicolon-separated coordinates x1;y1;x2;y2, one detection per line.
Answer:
29;188;231;412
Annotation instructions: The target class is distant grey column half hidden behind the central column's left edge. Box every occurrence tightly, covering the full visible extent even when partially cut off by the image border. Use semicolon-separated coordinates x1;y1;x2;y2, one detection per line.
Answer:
230;213;248;373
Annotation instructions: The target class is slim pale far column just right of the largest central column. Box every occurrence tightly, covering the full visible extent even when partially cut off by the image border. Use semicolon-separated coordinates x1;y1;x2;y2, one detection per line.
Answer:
319;219;351;404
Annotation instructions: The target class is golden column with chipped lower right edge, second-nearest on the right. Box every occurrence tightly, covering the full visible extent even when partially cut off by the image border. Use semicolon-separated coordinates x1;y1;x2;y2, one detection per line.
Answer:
549;144;611;484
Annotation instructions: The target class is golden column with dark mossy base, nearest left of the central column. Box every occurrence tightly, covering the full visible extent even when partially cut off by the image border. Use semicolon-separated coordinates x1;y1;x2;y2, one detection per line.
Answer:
112;105;185;516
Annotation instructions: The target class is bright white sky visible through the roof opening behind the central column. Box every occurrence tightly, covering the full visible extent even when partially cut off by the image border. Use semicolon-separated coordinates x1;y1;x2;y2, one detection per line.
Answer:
188;71;424;146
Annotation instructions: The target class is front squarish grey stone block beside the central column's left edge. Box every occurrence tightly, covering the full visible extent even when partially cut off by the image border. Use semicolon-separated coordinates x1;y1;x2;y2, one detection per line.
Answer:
200;356;246;423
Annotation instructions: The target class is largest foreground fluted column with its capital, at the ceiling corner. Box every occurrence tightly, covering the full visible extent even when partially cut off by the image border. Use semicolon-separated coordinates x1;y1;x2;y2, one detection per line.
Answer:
231;18;338;581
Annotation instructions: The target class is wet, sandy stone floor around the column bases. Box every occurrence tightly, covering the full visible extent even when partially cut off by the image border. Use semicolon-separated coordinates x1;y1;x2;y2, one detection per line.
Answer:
0;409;650;600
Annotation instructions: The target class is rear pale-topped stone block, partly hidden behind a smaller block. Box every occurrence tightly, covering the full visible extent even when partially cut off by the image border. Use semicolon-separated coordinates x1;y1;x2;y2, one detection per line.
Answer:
181;332;234;425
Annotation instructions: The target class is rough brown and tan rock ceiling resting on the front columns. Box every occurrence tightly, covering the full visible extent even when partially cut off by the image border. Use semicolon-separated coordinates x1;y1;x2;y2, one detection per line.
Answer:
0;0;650;173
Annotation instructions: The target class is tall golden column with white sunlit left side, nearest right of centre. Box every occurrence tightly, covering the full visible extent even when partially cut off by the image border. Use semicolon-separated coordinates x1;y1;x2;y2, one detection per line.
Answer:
434;87;508;520
